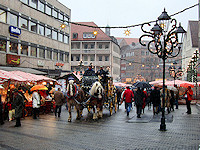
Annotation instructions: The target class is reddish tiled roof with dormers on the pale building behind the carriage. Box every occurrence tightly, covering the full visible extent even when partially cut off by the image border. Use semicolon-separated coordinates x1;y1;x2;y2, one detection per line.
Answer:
71;22;112;41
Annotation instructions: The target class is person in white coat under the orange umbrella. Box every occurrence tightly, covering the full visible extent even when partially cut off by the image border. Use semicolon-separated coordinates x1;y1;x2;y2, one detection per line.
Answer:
32;90;40;119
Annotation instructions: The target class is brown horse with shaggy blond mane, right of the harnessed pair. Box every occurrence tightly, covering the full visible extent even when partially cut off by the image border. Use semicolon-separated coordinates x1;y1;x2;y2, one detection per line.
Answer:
89;81;105;120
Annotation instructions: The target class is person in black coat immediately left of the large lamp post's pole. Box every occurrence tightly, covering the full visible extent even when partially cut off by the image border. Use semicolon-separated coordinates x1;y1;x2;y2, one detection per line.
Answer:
150;87;160;115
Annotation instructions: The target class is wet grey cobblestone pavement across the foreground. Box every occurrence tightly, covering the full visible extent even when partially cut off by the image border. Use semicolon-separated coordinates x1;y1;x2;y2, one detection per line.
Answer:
0;105;200;150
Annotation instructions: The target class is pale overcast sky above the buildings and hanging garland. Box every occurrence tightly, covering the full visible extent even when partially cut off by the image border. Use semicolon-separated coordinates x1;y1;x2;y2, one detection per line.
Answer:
58;0;199;38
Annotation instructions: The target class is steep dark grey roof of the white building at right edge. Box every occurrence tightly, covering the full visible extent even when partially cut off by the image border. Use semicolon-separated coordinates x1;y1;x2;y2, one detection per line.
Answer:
189;21;199;47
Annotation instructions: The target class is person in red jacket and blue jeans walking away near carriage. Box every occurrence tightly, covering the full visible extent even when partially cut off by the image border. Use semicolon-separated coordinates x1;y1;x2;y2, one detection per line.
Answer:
121;87;134;116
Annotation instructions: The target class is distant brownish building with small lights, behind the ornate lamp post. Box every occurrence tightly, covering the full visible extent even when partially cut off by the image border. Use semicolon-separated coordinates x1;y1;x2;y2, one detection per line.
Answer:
118;38;181;83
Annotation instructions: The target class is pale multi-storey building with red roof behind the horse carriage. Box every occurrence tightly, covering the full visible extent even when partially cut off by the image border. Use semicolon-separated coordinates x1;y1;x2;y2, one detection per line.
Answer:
71;22;120;79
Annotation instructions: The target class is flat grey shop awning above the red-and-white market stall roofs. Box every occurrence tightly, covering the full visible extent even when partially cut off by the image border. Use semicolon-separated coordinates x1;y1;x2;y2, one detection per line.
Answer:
0;66;47;75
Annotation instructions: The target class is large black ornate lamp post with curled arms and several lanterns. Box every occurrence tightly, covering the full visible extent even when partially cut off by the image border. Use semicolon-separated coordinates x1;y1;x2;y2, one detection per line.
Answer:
139;9;186;131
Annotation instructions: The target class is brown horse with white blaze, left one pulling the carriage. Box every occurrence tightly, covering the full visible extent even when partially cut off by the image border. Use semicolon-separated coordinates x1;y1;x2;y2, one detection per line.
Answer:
67;80;85;122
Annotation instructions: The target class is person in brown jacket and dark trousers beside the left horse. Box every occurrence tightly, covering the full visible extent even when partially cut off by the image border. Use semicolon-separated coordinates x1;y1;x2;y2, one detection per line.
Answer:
54;88;64;117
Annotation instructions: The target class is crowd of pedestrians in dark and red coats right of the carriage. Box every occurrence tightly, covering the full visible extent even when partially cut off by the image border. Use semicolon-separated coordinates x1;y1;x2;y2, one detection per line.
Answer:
117;85;193;118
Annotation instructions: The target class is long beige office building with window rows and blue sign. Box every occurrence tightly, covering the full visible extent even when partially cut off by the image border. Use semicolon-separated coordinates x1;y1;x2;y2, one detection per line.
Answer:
0;0;71;76
